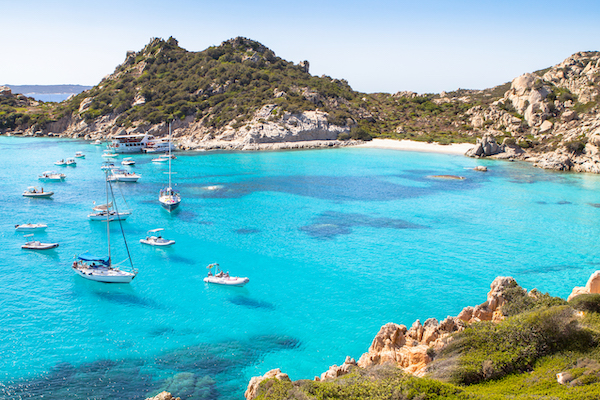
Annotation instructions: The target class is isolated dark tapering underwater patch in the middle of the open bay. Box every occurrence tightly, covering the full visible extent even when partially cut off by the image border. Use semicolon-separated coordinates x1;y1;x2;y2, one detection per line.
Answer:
299;211;425;239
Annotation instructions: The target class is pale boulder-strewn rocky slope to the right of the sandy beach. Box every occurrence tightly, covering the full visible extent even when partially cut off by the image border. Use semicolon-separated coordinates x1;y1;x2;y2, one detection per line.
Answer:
468;52;600;173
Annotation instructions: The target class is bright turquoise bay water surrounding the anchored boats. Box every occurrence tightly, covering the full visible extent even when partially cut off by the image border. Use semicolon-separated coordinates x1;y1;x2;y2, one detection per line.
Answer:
0;137;600;399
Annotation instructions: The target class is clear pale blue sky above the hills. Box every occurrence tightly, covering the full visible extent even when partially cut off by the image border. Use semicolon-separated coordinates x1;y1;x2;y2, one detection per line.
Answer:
0;0;600;93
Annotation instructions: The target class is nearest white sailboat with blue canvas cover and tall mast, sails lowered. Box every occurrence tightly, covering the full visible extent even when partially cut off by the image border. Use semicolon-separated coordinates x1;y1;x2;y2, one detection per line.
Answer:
71;170;138;283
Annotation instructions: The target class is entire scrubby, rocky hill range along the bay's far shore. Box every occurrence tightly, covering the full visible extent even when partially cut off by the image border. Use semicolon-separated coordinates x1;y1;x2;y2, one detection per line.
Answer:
0;37;600;173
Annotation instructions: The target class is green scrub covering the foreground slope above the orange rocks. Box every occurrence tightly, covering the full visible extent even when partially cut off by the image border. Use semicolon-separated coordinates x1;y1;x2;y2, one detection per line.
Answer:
256;286;600;400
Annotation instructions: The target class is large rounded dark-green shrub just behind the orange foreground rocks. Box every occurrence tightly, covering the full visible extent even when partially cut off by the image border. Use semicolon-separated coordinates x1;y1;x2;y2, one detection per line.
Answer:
431;306;598;385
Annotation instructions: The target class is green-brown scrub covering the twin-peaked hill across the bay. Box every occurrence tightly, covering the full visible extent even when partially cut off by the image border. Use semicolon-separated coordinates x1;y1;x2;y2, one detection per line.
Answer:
0;38;512;143
